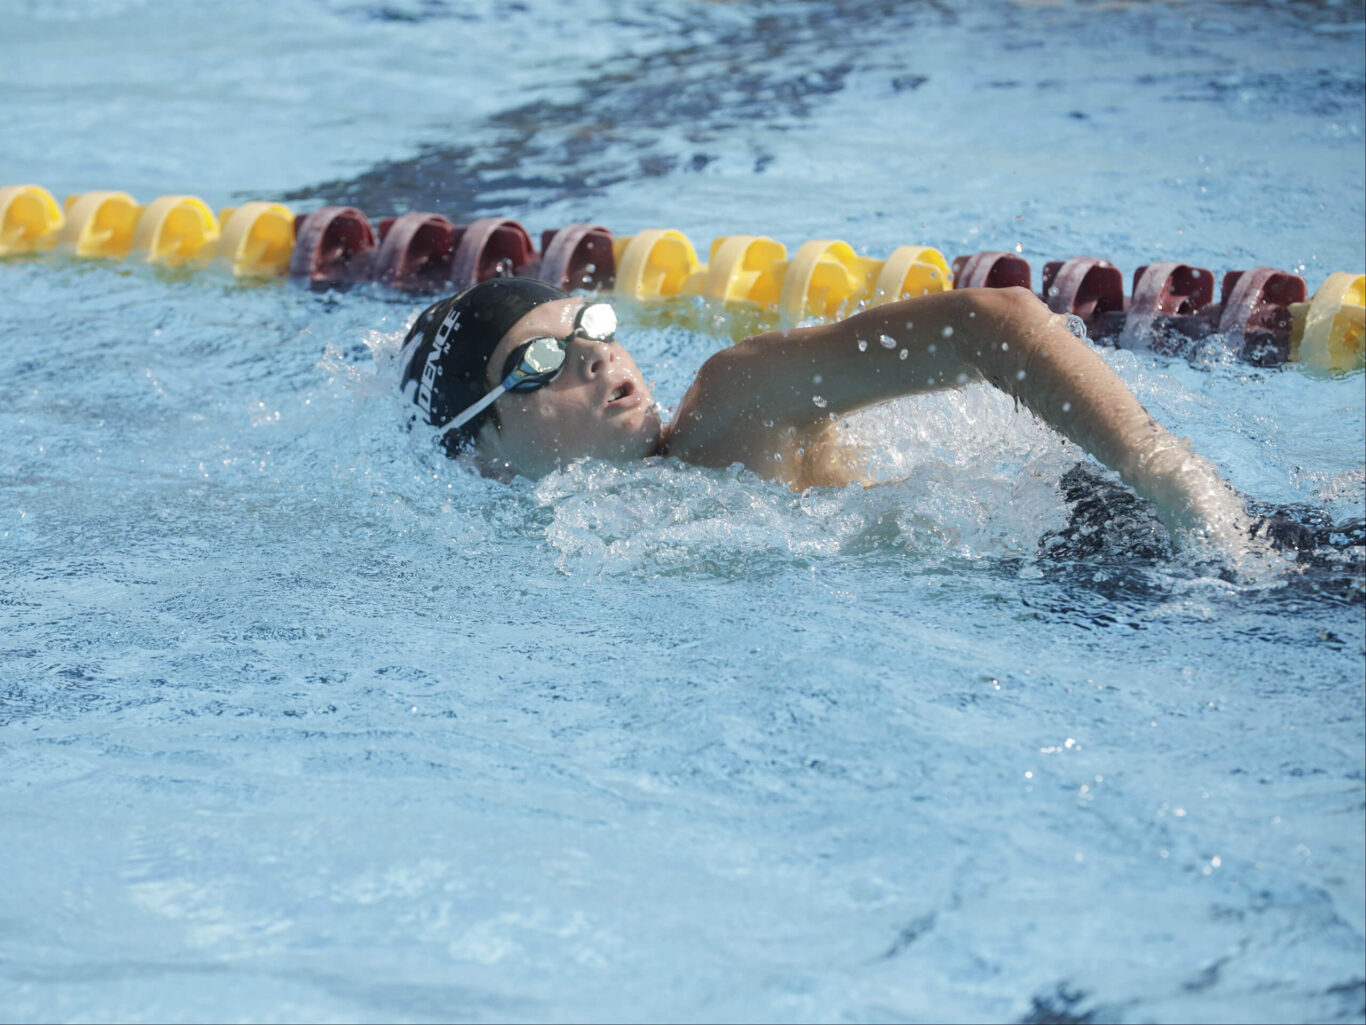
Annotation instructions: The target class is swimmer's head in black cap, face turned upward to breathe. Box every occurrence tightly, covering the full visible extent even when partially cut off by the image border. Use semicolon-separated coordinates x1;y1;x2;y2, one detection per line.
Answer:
402;277;660;476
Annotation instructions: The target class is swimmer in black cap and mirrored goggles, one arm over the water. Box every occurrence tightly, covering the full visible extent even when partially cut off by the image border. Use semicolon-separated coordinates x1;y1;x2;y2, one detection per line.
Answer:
402;279;1251;541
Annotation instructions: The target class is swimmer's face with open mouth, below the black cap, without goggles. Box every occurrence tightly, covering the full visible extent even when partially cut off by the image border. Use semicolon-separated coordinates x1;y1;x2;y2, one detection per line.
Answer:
478;297;660;476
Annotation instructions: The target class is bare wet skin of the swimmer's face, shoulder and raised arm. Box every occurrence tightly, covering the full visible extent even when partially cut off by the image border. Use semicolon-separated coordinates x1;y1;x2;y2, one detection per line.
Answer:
467;288;1246;554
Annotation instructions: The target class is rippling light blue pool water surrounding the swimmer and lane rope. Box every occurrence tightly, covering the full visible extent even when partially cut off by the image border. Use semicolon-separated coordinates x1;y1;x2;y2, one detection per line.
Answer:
0;0;1366;1022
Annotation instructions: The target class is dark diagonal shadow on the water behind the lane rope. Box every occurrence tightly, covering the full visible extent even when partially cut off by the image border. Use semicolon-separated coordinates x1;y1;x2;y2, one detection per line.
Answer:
284;0;958;220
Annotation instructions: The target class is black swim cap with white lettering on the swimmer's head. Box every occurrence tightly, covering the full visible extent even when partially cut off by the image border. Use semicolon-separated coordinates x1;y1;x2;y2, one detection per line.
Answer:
399;277;568;456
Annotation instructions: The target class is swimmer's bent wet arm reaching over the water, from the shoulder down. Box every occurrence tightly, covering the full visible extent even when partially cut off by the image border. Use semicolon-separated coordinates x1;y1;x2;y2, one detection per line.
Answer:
671;288;1244;534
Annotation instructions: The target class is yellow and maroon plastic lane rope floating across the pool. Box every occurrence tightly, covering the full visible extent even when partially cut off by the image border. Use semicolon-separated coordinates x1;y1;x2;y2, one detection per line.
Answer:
0;185;1366;370
